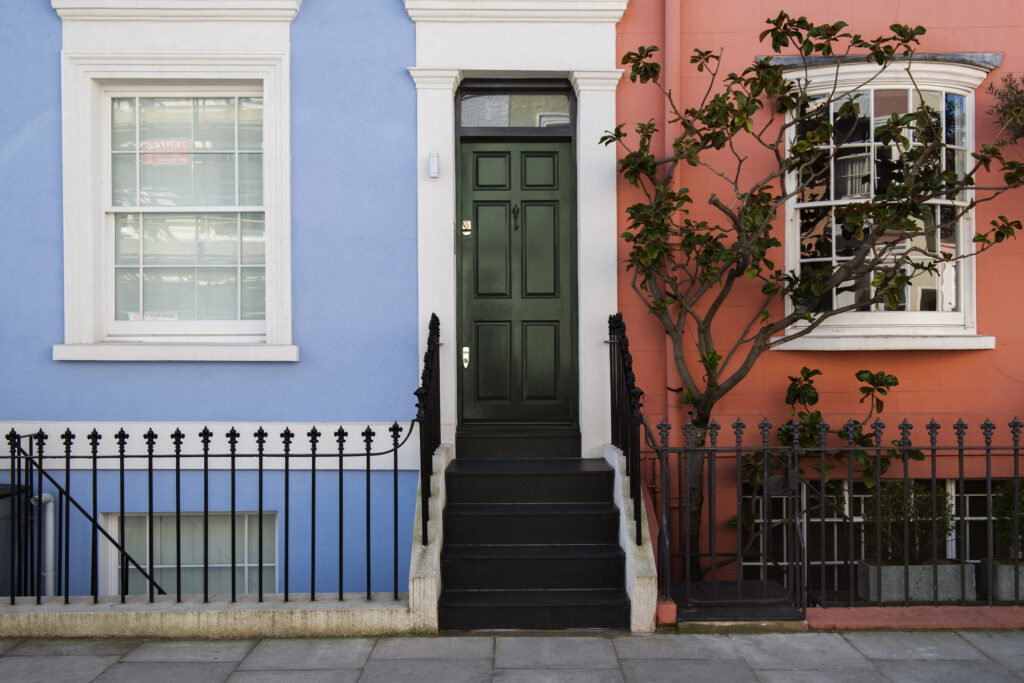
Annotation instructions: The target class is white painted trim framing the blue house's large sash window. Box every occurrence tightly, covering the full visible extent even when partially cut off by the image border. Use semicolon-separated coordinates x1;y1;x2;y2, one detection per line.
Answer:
53;0;298;360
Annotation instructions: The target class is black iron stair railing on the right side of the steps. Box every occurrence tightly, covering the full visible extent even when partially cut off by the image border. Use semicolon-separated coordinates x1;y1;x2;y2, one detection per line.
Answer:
608;313;644;546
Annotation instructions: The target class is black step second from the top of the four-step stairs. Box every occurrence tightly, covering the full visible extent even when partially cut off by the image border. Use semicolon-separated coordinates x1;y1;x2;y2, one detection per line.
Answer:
444;503;618;546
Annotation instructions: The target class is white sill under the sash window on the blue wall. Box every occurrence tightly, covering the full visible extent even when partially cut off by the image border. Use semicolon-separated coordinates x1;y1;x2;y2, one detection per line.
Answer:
53;342;299;362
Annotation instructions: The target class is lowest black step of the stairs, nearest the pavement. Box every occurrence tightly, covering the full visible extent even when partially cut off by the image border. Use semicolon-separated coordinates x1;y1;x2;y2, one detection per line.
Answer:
438;590;630;631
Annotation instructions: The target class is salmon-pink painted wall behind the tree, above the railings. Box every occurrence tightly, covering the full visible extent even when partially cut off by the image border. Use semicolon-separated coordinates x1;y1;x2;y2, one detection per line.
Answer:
617;0;1024;442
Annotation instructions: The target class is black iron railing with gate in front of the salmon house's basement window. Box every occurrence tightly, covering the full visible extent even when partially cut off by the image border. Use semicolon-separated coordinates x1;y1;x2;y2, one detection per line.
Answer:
651;419;1024;607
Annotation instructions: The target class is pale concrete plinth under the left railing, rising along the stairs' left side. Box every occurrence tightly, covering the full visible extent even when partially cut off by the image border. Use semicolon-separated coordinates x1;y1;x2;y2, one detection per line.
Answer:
0;444;455;639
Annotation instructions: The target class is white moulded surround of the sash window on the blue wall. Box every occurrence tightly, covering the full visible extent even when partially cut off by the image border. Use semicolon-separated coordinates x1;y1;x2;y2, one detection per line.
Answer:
51;0;301;361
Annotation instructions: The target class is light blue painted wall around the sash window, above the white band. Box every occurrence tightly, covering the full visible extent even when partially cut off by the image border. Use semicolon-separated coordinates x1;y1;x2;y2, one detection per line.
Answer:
0;0;426;422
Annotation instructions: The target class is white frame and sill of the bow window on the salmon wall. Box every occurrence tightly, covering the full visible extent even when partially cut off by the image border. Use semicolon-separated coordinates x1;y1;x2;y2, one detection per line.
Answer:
774;59;995;351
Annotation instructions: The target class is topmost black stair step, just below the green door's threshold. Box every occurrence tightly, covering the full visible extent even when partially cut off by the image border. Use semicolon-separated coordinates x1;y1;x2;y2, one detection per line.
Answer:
445;458;614;503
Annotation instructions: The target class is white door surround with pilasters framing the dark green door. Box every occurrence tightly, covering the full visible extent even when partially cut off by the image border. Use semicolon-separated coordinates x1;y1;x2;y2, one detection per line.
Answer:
406;0;628;458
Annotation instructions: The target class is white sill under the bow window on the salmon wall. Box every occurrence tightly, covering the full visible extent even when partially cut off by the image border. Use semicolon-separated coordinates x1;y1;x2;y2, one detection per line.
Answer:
772;327;995;351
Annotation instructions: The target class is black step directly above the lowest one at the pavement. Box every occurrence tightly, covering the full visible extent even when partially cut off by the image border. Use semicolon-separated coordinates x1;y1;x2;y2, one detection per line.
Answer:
441;544;626;590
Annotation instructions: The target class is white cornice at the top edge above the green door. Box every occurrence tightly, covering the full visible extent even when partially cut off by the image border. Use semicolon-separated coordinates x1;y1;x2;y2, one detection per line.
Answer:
404;0;629;24
